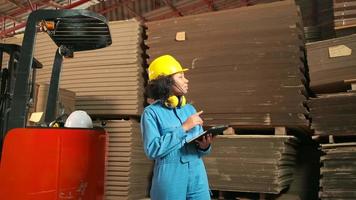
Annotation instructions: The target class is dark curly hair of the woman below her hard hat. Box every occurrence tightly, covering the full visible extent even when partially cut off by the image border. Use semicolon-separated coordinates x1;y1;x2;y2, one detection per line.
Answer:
146;76;174;102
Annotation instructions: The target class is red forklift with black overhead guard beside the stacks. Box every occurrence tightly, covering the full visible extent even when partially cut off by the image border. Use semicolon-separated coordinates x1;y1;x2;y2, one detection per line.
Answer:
0;10;112;200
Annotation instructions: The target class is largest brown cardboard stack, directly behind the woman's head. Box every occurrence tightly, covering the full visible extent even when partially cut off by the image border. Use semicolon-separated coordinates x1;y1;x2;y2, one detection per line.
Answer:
147;1;309;130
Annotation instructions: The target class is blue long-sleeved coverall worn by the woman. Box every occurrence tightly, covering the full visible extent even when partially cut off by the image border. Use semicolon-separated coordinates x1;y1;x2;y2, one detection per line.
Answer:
141;101;211;200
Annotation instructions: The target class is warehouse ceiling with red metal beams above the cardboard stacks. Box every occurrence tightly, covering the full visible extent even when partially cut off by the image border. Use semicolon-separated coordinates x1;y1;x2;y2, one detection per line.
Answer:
0;0;268;39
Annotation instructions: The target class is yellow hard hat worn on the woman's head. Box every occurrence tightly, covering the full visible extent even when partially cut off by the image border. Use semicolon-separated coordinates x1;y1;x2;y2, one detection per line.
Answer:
148;55;188;81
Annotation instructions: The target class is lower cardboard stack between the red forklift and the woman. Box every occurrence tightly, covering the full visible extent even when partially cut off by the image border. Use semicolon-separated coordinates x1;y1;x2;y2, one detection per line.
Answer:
94;120;152;200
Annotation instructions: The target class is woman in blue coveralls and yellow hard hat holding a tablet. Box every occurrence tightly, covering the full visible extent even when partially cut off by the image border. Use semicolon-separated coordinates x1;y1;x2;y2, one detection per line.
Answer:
141;55;212;200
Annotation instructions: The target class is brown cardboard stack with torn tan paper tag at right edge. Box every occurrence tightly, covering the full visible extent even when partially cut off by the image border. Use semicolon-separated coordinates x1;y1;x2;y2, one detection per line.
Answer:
306;34;356;93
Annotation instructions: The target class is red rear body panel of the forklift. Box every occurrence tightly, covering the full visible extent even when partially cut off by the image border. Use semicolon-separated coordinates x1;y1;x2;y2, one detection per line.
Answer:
0;128;107;200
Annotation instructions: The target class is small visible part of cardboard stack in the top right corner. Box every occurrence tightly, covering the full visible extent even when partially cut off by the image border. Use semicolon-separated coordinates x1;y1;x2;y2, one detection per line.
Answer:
334;0;356;29
